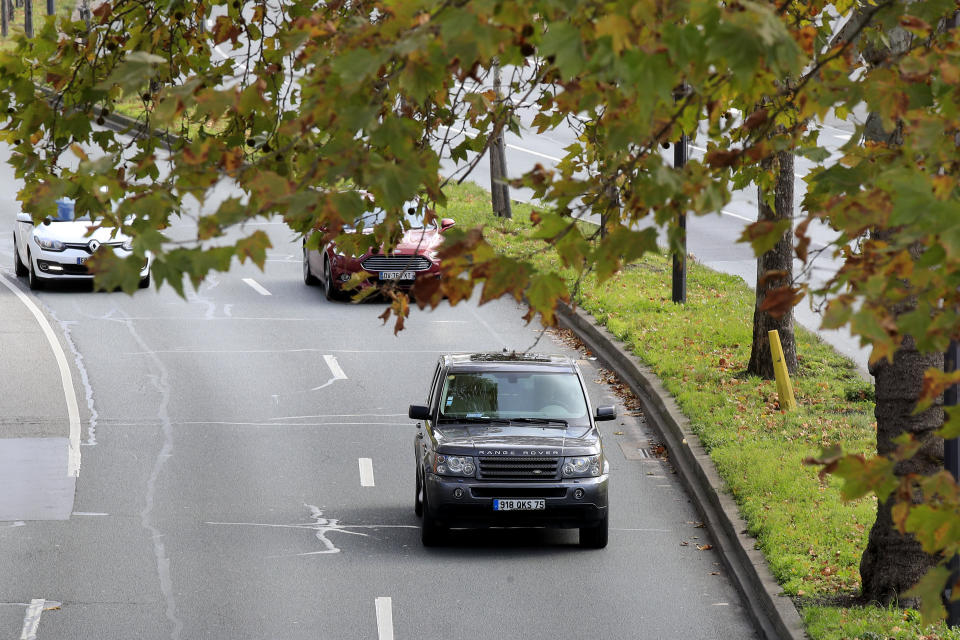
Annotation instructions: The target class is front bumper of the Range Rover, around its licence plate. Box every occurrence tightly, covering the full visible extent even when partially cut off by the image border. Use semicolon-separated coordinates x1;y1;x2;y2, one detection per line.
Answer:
424;473;609;529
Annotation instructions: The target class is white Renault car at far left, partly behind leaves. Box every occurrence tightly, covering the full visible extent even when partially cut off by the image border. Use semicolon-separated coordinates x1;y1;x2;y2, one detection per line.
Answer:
13;199;151;289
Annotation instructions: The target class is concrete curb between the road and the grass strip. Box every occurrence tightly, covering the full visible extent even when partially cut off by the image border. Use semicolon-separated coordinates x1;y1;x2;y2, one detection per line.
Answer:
557;304;807;640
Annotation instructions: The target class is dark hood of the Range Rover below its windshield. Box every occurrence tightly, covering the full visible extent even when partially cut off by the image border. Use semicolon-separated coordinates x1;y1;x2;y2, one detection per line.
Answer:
434;424;600;456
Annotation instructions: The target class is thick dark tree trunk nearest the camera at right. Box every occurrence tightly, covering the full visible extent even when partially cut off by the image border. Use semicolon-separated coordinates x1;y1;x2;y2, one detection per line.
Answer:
860;336;943;604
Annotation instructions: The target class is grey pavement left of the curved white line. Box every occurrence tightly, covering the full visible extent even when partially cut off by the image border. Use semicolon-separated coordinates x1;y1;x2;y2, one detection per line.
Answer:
0;268;76;522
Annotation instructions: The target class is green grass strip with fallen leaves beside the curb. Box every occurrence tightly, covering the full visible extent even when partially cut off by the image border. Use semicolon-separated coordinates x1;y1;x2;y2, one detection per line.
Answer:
440;180;960;640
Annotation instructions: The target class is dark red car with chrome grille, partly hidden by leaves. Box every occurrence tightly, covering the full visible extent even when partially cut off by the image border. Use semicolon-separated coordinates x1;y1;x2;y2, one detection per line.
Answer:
303;200;454;300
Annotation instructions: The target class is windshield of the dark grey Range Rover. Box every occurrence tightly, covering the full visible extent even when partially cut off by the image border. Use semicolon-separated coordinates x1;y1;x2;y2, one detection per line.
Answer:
440;371;587;425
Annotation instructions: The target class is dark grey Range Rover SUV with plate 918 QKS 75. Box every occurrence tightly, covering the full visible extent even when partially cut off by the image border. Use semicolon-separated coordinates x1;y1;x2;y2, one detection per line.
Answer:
409;353;616;548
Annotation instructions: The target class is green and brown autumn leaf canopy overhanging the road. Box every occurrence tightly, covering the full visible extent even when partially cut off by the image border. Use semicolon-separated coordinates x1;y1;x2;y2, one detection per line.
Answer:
0;0;960;620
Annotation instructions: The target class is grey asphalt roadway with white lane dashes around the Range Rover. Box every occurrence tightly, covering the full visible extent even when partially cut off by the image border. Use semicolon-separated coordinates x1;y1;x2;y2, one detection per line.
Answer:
0;146;754;640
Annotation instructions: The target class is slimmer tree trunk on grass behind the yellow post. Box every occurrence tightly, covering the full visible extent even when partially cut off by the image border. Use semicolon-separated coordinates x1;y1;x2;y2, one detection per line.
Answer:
747;151;797;380
